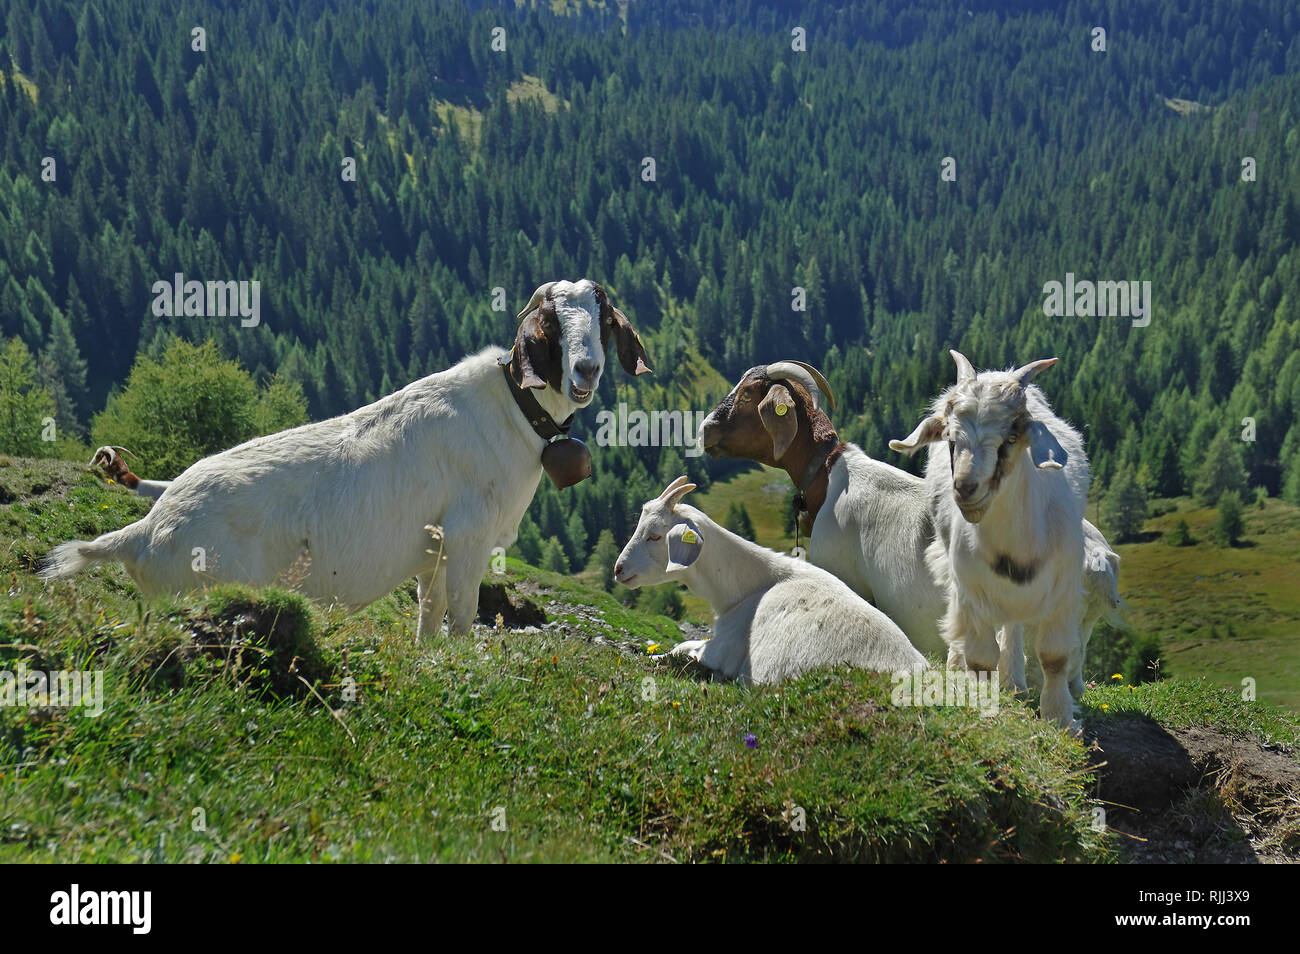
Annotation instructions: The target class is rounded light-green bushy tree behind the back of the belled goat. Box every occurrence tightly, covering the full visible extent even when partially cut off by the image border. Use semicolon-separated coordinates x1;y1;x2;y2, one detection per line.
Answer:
91;339;306;480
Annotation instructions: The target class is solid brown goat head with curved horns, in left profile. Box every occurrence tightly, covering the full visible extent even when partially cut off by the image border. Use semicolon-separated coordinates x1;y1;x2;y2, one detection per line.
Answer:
699;361;835;467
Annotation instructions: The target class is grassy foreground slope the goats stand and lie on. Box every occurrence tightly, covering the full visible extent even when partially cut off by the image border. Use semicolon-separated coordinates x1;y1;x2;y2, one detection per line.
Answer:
0;459;1300;862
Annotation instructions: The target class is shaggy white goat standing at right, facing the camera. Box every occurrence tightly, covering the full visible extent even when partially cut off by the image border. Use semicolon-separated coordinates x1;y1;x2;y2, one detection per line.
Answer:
889;351;1091;729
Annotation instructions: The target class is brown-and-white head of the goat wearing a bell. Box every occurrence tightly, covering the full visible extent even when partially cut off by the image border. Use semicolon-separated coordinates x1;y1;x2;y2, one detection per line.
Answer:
502;278;650;407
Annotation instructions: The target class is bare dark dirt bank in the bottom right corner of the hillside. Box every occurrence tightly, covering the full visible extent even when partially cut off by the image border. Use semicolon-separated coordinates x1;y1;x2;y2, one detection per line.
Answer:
1093;716;1300;864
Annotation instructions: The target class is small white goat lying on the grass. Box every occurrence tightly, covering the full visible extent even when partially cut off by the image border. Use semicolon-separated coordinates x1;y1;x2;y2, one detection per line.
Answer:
614;477;926;682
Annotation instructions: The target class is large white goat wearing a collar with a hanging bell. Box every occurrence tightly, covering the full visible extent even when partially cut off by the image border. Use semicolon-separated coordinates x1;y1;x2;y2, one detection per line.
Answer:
42;279;650;647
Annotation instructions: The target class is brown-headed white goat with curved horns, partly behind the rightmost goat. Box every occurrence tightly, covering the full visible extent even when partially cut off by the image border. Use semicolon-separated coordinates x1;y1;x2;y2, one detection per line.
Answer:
699;361;1118;697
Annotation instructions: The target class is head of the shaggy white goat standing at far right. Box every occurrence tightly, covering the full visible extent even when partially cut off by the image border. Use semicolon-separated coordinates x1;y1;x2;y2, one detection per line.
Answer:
889;351;1067;524
